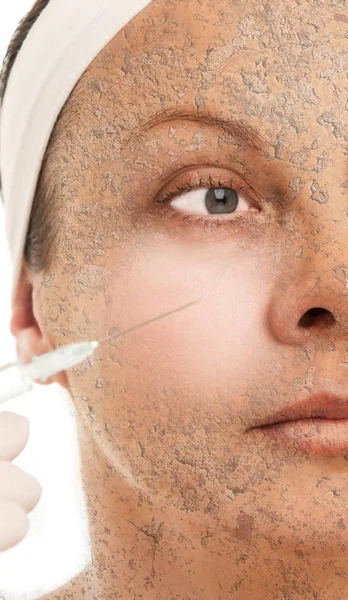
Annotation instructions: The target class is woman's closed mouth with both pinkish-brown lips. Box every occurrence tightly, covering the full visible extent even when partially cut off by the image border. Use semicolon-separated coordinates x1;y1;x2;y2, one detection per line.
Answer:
249;391;348;455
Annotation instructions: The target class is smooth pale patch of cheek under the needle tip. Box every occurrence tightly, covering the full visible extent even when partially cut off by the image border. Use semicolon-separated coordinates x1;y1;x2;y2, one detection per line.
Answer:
100;243;269;391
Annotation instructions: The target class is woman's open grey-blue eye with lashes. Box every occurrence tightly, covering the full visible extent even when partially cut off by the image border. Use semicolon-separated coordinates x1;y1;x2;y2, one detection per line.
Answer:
156;174;260;226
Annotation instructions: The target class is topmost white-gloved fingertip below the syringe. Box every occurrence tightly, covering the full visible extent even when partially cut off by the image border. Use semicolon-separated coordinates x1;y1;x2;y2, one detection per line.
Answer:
0;411;30;461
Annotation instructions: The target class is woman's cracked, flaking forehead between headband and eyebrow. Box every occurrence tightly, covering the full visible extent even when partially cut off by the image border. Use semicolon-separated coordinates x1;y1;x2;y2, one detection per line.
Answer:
77;0;348;125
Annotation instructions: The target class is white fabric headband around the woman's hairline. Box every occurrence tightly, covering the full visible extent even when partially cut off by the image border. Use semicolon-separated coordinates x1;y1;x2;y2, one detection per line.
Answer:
0;0;151;305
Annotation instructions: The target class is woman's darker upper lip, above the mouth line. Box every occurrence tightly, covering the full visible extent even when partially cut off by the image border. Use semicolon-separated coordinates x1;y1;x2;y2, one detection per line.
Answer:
254;391;348;427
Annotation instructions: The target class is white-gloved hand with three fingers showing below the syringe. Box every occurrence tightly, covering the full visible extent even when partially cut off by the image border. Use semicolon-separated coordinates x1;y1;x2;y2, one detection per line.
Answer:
0;411;42;552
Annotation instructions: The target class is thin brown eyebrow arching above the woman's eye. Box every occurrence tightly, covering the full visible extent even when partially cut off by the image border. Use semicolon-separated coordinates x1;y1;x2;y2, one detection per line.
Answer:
122;109;270;156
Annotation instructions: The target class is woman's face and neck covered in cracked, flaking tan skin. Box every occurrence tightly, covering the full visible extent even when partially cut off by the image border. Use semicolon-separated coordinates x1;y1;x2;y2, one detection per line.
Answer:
17;0;348;600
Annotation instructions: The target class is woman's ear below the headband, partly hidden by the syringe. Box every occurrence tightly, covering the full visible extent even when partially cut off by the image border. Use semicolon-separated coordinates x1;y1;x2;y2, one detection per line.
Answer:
10;261;68;388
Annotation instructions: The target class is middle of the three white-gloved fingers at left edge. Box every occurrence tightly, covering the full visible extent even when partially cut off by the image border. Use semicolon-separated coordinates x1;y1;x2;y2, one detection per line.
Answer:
0;460;42;513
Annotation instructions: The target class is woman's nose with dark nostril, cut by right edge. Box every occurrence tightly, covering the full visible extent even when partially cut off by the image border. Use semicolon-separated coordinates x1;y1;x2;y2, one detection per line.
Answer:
268;222;348;346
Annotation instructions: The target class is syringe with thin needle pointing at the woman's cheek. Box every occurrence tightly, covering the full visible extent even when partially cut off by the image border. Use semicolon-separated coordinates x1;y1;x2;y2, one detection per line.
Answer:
0;301;198;404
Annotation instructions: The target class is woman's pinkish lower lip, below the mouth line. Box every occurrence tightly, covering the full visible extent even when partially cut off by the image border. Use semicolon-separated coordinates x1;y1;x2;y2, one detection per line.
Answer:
254;418;348;455
